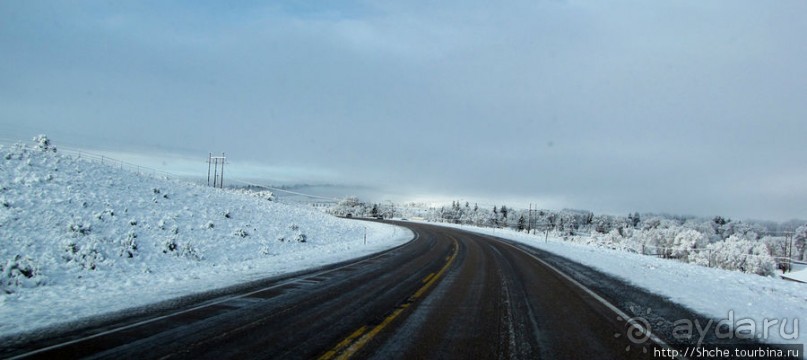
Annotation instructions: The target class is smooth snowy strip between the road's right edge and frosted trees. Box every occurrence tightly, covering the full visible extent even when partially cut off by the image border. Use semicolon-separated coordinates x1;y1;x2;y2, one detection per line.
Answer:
426;224;807;348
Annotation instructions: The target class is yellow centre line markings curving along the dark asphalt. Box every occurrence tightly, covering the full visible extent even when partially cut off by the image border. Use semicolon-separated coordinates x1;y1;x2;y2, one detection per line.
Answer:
319;239;459;360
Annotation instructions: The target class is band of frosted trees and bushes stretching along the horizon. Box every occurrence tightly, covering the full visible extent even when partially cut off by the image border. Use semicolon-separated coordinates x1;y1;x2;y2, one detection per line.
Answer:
328;196;807;276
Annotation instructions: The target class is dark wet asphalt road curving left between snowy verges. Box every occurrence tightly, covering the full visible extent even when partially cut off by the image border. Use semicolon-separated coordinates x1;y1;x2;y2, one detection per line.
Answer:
0;223;724;359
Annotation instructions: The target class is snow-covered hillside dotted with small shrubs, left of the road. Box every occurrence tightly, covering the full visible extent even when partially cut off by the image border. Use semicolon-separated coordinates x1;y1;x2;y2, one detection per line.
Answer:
0;141;412;336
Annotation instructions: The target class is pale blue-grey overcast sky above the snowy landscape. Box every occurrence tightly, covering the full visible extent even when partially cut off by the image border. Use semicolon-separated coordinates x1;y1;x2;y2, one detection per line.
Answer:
0;0;807;220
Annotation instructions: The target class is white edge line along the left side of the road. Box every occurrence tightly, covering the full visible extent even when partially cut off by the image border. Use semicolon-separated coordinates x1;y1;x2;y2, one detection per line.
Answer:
8;233;420;360
